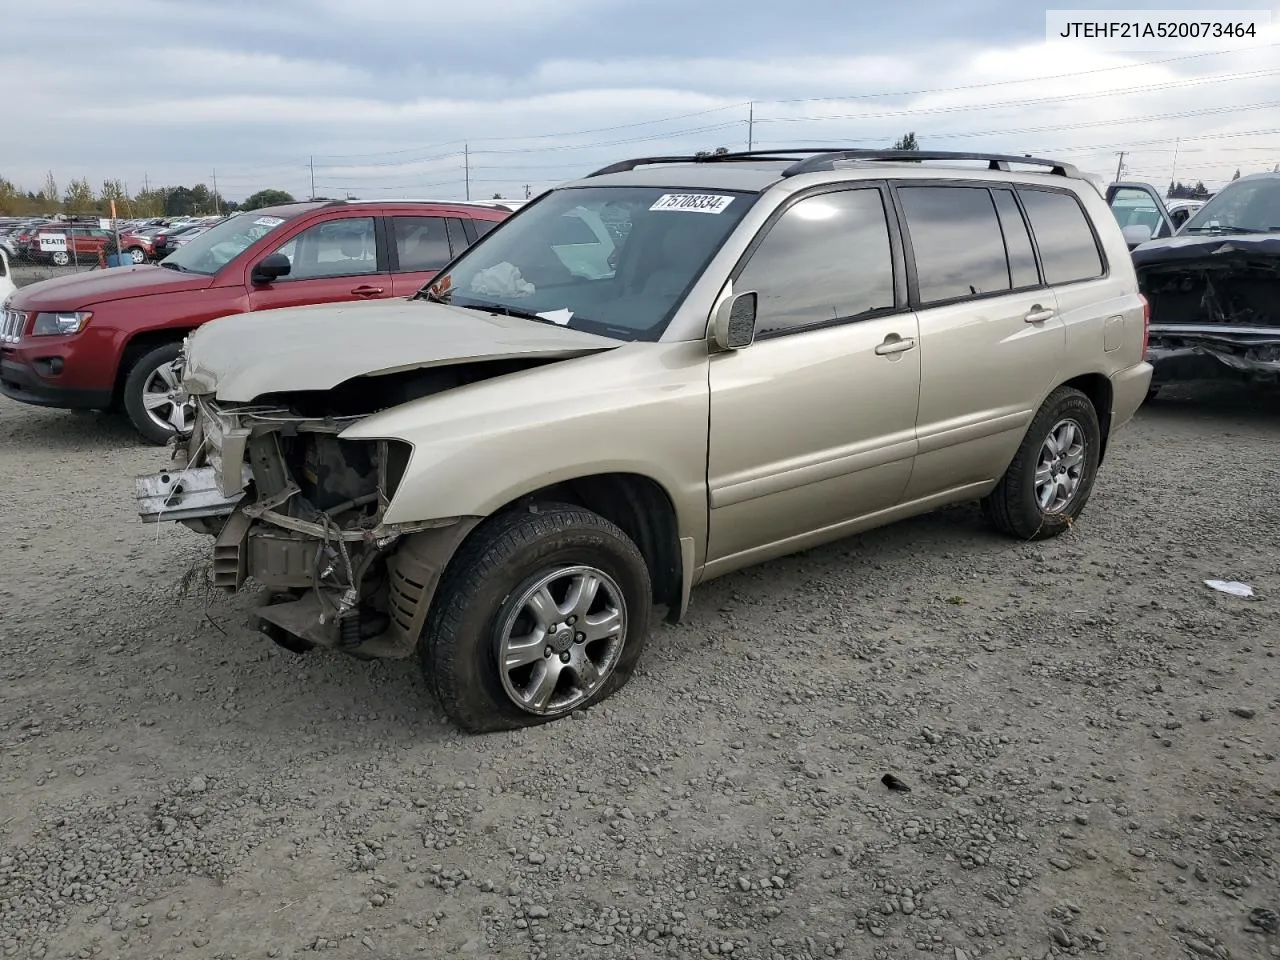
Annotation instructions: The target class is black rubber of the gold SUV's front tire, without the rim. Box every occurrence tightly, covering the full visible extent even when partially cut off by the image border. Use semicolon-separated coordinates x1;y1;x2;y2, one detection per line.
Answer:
419;503;653;733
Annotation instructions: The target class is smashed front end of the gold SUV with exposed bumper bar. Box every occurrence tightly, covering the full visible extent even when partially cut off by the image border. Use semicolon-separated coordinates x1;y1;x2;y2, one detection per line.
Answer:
136;396;476;657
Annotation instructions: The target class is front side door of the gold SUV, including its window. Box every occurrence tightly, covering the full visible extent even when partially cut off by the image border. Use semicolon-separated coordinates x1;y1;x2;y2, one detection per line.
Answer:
707;184;920;568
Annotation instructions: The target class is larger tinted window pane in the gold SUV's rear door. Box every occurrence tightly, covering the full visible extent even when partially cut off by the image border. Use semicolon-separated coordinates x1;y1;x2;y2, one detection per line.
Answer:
897;187;1010;303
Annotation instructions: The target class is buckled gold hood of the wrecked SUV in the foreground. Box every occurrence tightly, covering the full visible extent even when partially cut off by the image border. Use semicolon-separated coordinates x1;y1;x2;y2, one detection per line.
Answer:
183;298;623;403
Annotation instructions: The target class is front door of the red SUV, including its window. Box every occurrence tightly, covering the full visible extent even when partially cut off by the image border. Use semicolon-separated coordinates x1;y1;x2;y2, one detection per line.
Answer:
246;214;393;310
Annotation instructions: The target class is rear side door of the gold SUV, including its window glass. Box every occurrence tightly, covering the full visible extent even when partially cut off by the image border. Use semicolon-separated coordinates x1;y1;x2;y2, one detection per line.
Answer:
896;182;1070;500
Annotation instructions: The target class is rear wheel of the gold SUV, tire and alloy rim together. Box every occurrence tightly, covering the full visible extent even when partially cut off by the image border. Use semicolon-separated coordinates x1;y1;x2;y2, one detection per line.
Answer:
982;387;1102;540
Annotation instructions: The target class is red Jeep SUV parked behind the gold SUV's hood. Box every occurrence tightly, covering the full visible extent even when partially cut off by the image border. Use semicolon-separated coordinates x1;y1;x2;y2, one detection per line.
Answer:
0;200;511;444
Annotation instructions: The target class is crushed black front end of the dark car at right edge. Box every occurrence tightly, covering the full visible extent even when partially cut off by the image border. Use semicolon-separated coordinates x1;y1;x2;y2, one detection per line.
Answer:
1134;248;1280;387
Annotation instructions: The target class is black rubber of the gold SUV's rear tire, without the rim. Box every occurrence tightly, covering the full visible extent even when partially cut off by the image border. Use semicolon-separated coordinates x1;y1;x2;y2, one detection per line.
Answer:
982;387;1102;540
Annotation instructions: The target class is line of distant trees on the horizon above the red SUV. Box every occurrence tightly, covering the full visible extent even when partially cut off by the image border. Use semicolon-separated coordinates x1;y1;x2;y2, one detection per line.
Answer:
0;172;302;219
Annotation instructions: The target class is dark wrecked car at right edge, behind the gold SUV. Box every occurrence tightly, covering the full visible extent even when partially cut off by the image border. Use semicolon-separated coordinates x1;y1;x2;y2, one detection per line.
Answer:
1133;173;1280;396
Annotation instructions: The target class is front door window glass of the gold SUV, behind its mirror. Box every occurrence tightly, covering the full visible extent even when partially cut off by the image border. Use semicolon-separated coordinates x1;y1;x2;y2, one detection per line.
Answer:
733;188;893;337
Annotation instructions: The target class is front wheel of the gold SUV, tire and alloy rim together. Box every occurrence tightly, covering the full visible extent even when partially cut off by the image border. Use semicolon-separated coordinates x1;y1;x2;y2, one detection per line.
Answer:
419;504;653;733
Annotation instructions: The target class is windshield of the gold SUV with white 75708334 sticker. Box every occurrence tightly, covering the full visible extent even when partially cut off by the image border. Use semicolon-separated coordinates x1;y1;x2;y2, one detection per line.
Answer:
424;187;755;340
